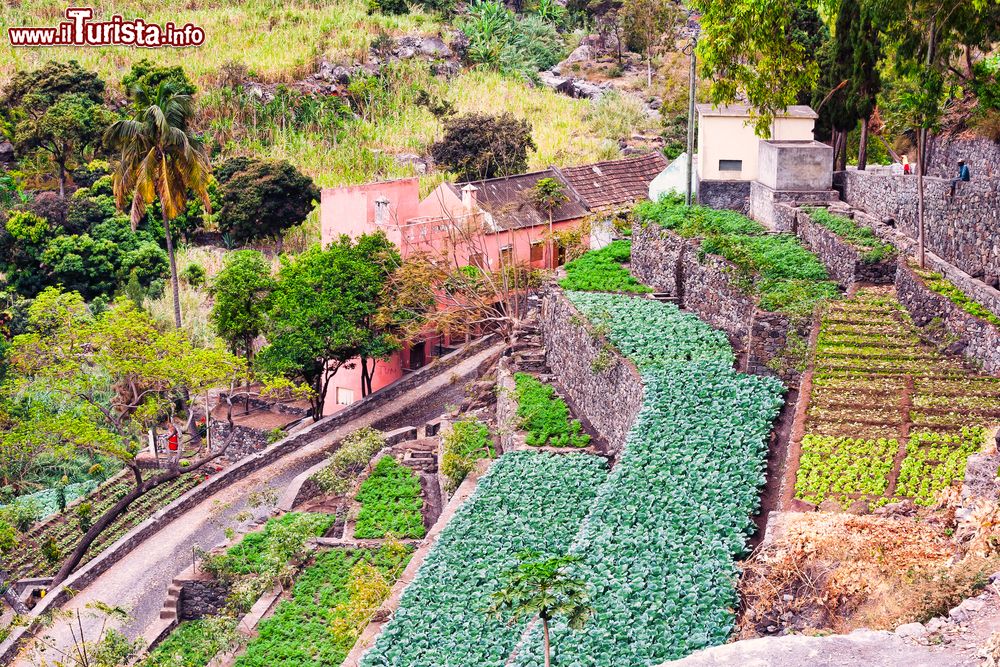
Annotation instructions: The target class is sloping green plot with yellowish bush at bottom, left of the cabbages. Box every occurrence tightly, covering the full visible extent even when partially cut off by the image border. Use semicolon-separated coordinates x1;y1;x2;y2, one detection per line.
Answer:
236;545;411;667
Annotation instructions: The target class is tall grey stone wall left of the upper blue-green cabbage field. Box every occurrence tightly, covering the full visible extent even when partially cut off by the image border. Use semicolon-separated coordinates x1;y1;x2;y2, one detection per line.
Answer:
541;289;644;456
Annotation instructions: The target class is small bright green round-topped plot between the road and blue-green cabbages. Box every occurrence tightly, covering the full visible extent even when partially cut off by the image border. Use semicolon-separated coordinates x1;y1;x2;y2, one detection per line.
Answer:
354;455;427;539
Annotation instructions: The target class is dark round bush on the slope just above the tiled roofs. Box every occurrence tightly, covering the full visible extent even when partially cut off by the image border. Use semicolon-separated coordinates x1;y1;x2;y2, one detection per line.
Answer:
431;113;536;181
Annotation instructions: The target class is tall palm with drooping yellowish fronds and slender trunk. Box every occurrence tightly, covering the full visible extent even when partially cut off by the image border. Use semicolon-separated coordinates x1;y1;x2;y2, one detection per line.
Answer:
104;81;211;328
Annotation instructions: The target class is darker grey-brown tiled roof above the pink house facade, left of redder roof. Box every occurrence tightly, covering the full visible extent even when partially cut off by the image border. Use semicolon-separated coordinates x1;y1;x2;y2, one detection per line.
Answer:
450;169;587;230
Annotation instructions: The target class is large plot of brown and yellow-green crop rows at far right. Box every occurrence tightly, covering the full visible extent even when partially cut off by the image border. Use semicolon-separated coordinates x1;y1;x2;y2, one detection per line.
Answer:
795;288;1000;507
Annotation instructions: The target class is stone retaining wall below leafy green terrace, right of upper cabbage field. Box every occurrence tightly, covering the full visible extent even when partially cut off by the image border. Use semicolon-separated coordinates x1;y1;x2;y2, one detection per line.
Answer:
631;223;808;384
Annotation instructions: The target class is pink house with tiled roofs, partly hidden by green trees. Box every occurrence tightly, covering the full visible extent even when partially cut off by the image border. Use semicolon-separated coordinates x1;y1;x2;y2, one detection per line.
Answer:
320;153;667;414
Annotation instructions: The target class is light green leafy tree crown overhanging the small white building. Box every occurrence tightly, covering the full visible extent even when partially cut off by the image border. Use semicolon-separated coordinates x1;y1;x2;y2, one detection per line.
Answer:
690;0;819;137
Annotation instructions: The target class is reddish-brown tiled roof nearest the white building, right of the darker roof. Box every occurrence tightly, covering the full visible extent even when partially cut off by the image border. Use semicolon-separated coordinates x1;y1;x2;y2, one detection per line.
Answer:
556;151;669;211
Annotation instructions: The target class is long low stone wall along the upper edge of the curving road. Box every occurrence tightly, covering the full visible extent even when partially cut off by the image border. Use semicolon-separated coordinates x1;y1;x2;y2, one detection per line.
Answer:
0;336;494;664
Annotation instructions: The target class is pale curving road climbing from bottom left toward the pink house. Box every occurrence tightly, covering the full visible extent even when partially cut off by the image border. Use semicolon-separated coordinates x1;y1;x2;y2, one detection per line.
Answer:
14;347;499;667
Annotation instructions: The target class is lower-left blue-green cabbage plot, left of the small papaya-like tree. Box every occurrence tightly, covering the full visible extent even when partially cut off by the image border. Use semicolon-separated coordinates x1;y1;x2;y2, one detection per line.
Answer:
361;451;607;667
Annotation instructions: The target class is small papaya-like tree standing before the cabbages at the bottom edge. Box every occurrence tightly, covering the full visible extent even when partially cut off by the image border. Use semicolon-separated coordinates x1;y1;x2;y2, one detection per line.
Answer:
487;551;594;667
